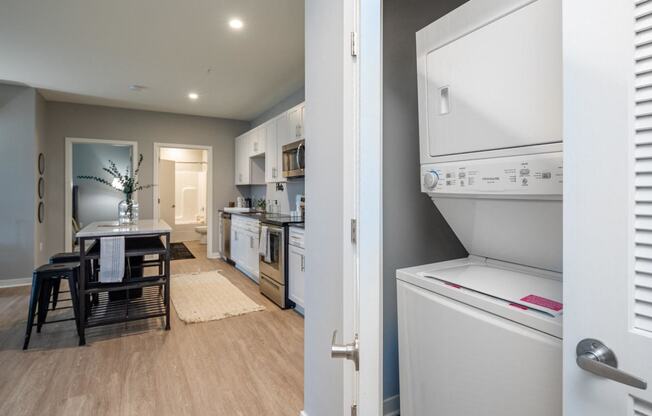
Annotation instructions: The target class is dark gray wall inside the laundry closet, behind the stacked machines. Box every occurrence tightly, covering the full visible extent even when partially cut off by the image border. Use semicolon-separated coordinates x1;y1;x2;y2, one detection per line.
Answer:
383;0;467;404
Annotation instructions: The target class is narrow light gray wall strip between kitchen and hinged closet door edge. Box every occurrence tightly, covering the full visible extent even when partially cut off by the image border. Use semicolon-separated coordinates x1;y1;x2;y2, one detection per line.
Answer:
304;0;345;416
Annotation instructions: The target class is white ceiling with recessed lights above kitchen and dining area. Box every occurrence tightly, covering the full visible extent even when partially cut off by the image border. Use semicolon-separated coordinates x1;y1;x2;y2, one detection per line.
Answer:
0;0;304;120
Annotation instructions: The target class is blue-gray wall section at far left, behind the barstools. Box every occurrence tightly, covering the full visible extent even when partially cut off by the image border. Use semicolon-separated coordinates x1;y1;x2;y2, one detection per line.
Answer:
0;84;38;279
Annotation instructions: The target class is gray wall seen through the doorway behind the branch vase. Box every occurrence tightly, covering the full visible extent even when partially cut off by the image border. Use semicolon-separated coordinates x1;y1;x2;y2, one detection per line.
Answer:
72;143;132;227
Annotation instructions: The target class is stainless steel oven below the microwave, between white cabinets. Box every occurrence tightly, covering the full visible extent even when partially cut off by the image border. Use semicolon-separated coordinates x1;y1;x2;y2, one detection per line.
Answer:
258;224;287;309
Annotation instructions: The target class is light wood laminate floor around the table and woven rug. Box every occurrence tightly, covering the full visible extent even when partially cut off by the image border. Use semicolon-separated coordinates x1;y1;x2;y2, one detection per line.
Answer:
0;242;303;416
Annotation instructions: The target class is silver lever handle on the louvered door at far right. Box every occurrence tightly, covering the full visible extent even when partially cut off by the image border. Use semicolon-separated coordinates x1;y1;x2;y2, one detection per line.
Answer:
576;338;647;390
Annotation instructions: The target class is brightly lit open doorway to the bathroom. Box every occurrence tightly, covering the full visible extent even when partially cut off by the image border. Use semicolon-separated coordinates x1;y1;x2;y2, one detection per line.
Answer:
153;143;216;258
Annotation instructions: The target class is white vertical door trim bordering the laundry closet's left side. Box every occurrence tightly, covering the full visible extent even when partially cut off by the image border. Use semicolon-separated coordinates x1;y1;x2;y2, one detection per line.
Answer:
356;0;383;416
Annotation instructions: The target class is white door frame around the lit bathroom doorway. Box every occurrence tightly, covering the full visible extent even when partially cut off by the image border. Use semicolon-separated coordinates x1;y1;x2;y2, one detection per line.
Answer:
152;142;214;259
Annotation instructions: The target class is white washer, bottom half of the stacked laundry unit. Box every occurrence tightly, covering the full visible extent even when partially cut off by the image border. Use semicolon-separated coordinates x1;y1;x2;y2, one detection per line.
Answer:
397;256;562;416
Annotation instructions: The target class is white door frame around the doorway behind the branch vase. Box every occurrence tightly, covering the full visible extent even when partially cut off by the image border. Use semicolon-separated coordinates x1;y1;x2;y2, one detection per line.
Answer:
64;137;139;251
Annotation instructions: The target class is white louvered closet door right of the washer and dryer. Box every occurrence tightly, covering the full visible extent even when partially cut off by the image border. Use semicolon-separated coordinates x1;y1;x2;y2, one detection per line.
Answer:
560;0;652;416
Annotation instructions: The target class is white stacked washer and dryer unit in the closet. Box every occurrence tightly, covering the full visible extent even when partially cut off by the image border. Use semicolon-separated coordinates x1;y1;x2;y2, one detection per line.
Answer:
397;0;563;416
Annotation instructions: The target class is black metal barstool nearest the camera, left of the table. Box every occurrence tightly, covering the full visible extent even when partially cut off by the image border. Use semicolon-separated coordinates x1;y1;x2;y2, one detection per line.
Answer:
23;262;79;350
